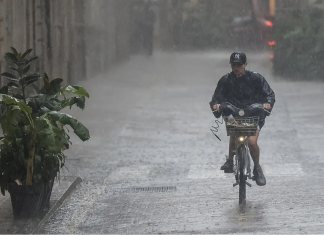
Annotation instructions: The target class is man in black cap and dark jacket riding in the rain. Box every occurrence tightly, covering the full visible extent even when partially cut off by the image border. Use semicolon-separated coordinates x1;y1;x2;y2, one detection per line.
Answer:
209;52;275;186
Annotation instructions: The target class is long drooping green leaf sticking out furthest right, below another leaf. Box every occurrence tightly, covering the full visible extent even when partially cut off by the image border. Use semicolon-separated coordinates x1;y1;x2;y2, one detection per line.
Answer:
46;111;90;141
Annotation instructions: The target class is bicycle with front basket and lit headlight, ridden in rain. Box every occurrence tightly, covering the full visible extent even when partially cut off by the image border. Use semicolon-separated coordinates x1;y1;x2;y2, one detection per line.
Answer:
213;102;270;205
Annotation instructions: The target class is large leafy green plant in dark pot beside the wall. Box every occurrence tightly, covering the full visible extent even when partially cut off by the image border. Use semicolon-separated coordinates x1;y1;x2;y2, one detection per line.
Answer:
0;48;90;218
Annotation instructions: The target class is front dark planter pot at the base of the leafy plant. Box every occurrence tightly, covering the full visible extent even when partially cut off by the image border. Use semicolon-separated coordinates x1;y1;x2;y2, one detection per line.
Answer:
8;184;44;219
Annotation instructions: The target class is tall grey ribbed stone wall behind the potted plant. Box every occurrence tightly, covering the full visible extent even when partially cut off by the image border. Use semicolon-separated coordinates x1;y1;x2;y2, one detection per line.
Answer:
0;0;130;82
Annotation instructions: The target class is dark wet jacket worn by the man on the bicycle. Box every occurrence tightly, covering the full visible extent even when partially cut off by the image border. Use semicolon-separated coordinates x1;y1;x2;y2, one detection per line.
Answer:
209;70;275;108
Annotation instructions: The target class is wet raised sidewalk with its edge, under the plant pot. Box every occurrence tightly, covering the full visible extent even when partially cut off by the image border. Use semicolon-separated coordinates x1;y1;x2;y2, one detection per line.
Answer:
0;177;81;234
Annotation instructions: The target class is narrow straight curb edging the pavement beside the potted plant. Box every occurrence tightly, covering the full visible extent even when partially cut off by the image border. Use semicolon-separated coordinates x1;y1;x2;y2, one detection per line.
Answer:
31;177;82;234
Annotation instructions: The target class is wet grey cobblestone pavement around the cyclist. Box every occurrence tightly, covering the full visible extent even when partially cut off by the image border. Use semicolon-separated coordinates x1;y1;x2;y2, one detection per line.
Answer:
41;52;324;234
